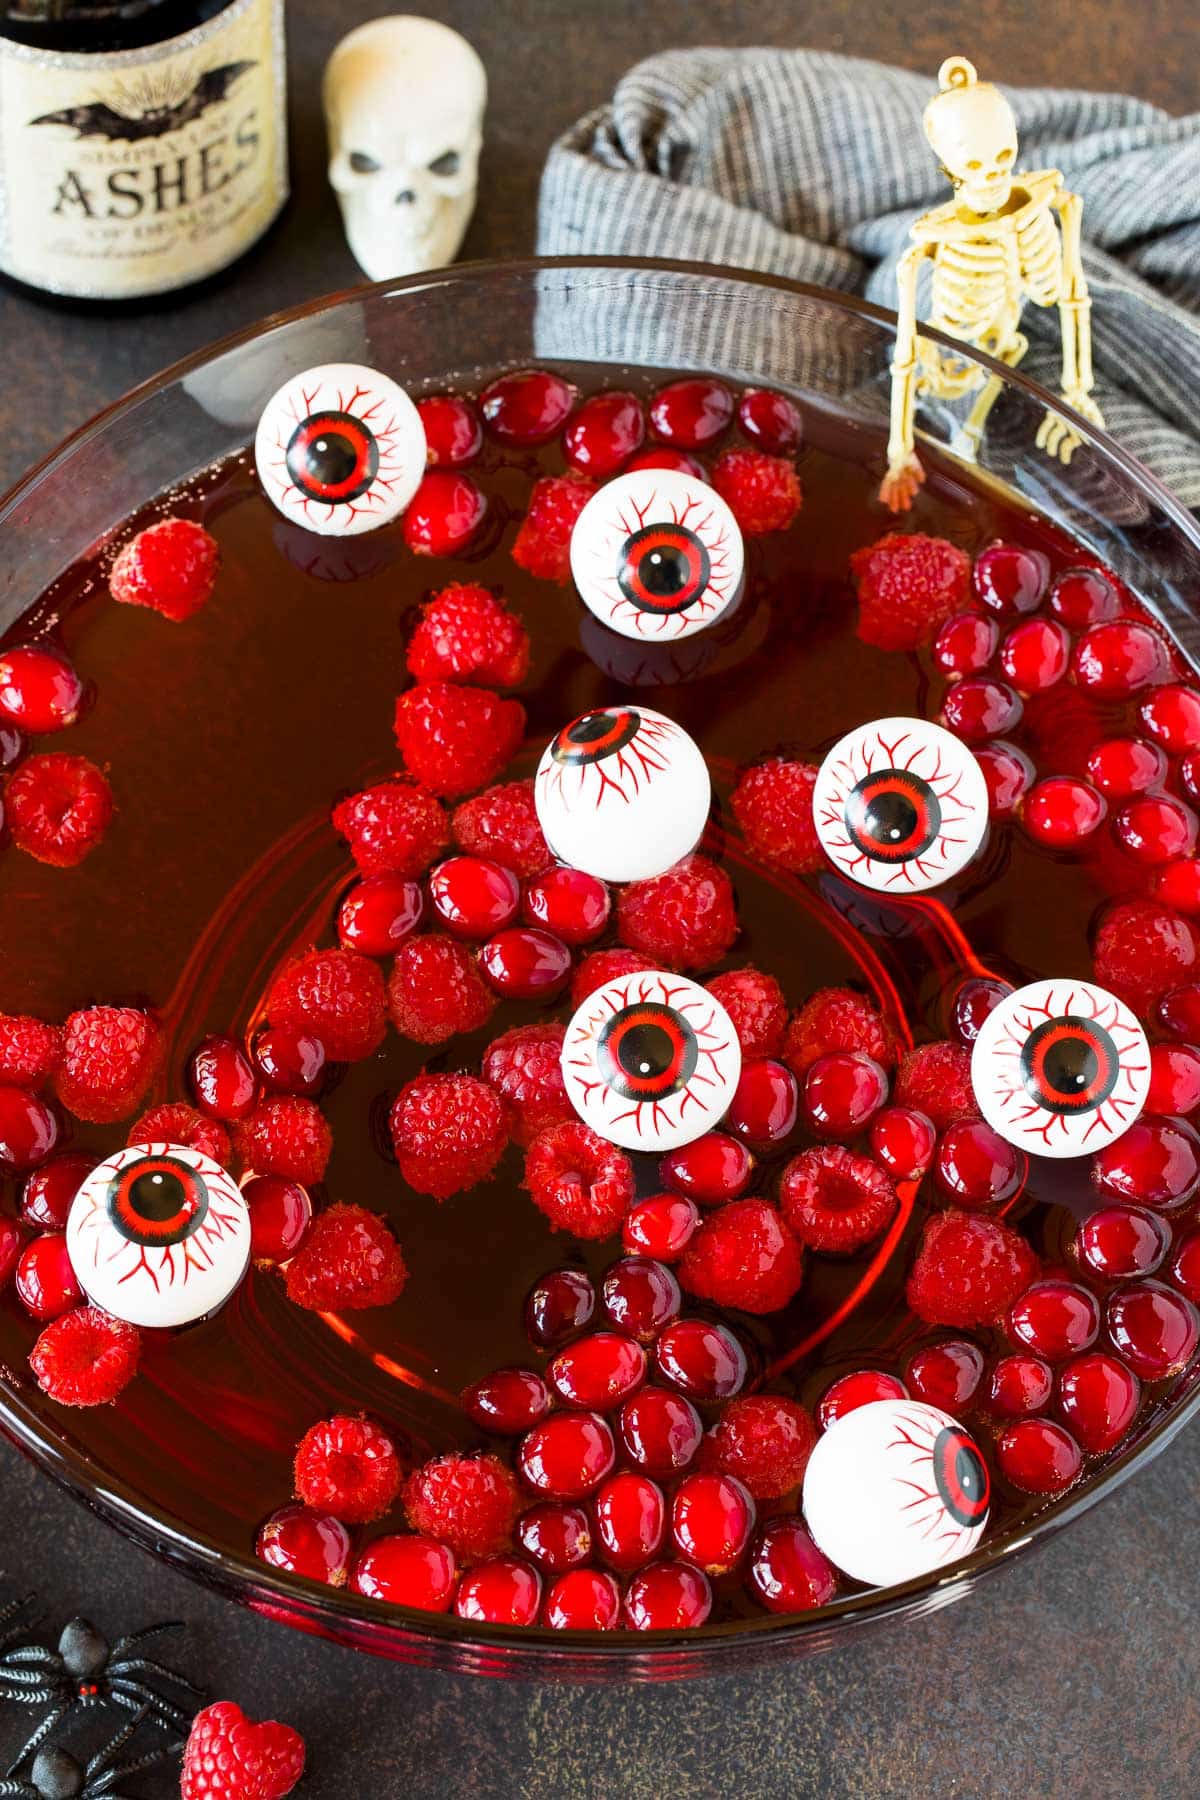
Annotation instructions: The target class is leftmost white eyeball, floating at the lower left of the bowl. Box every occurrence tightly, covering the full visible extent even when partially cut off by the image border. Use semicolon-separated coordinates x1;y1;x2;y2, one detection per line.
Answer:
67;1143;250;1327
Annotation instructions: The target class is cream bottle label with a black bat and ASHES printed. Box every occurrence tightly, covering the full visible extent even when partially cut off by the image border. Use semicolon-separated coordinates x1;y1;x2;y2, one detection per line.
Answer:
0;0;288;301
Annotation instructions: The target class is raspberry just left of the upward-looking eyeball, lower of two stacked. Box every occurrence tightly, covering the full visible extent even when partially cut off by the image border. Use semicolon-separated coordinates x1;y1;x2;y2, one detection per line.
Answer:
396;680;525;797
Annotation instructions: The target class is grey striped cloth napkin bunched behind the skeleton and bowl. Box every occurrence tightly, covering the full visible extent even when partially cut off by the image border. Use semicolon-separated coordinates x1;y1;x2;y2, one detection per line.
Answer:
538;45;1200;508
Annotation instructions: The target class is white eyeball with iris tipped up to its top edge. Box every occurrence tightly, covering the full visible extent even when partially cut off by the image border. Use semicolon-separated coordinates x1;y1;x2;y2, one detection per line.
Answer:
533;706;712;882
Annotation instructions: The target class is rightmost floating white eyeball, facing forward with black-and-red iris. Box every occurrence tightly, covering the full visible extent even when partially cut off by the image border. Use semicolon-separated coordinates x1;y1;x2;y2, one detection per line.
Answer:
972;981;1150;1156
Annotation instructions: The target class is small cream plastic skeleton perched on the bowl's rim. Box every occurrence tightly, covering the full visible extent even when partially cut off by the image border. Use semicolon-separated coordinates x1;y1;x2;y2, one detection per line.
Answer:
880;56;1105;513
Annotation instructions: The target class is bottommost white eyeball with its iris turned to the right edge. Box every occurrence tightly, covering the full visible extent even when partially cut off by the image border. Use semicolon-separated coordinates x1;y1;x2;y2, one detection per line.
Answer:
804;1400;991;1588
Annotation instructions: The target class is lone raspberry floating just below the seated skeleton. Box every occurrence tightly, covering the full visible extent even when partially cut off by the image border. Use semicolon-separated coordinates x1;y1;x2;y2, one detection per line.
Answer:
849;531;972;650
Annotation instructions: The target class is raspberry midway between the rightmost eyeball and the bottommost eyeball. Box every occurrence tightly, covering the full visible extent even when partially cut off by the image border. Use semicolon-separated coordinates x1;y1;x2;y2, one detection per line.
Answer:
907;1206;1038;1327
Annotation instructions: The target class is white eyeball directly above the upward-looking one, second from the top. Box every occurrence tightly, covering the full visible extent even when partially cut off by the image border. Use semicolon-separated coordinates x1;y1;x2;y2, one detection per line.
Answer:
570;468;745;643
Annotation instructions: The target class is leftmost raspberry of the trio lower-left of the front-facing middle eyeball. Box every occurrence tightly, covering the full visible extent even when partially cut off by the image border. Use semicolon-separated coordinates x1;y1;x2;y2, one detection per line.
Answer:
390;1075;509;1201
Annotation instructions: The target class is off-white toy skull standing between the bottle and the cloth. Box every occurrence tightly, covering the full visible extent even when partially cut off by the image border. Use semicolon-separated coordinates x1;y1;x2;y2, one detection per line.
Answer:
324;14;488;281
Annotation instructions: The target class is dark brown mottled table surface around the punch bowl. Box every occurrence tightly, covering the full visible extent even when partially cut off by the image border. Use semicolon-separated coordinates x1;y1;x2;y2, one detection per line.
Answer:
0;0;1200;1800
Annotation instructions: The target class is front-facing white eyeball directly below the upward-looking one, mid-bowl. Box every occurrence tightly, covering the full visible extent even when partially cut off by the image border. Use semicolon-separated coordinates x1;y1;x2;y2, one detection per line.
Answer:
561;970;741;1152
